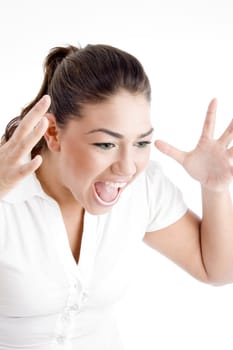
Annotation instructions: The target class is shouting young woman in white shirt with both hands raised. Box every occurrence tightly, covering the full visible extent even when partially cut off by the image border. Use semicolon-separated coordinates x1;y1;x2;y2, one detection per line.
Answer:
0;45;233;350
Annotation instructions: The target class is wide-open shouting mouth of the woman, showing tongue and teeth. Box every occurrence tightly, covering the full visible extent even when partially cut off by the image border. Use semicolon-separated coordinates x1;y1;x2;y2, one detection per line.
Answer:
94;181;126;206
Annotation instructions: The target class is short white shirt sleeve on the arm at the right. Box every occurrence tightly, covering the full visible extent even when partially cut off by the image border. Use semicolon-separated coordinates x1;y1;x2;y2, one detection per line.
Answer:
146;161;187;232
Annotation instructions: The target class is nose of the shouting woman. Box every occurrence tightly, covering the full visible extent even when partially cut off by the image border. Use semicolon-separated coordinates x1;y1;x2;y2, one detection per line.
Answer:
112;151;137;177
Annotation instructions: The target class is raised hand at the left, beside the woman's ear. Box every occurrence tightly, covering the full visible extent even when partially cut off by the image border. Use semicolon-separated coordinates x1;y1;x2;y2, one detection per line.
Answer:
0;95;50;198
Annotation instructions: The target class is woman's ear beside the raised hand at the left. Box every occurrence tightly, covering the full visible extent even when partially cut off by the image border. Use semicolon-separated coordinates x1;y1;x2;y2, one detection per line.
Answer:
44;113;60;152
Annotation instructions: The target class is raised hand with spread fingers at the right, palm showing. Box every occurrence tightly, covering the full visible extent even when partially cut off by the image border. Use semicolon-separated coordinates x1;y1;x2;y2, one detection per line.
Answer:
155;99;233;192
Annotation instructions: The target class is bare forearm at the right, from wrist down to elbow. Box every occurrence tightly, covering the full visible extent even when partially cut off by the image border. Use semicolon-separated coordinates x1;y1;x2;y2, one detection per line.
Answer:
201;189;233;284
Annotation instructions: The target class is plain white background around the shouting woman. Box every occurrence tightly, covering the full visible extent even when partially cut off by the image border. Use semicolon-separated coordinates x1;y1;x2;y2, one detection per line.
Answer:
0;0;233;350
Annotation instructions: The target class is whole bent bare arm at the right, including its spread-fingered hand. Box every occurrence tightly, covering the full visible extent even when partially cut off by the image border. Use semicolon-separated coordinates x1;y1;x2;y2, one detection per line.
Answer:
145;99;233;284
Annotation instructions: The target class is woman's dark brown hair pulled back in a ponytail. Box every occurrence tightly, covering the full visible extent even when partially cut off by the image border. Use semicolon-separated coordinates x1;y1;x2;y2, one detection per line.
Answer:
3;45;151;156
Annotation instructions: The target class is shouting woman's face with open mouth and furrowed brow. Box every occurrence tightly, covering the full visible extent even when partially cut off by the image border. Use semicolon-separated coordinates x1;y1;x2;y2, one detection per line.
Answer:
54;91;153;214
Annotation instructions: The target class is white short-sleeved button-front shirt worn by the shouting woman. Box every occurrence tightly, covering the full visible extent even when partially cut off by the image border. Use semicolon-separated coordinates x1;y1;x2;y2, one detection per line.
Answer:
0;161;187;350
